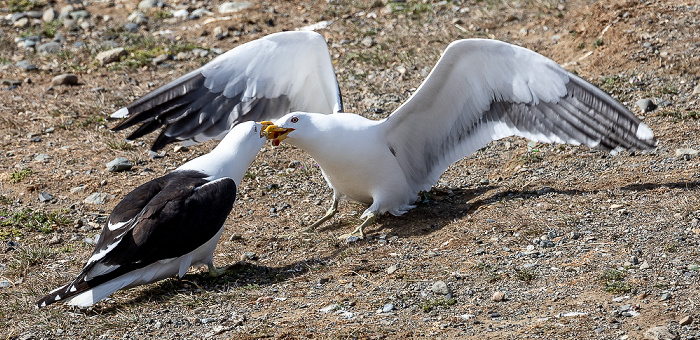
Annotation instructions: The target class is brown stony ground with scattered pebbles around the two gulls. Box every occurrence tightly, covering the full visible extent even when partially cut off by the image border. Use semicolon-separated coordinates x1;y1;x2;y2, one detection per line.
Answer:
0;0;700;340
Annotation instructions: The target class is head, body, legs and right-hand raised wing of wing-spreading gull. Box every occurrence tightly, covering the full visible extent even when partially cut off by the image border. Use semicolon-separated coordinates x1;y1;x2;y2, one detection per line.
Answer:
266;39;657;238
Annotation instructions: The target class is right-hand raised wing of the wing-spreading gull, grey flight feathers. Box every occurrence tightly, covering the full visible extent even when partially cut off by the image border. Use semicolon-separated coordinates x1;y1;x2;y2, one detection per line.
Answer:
382;39;656;190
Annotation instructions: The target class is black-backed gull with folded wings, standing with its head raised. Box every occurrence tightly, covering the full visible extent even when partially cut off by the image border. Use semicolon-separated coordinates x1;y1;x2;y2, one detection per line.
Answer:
37;122;266;308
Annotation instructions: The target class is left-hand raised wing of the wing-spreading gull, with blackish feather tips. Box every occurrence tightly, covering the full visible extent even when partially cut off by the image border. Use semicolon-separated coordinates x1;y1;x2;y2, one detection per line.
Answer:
110;31;343;152
